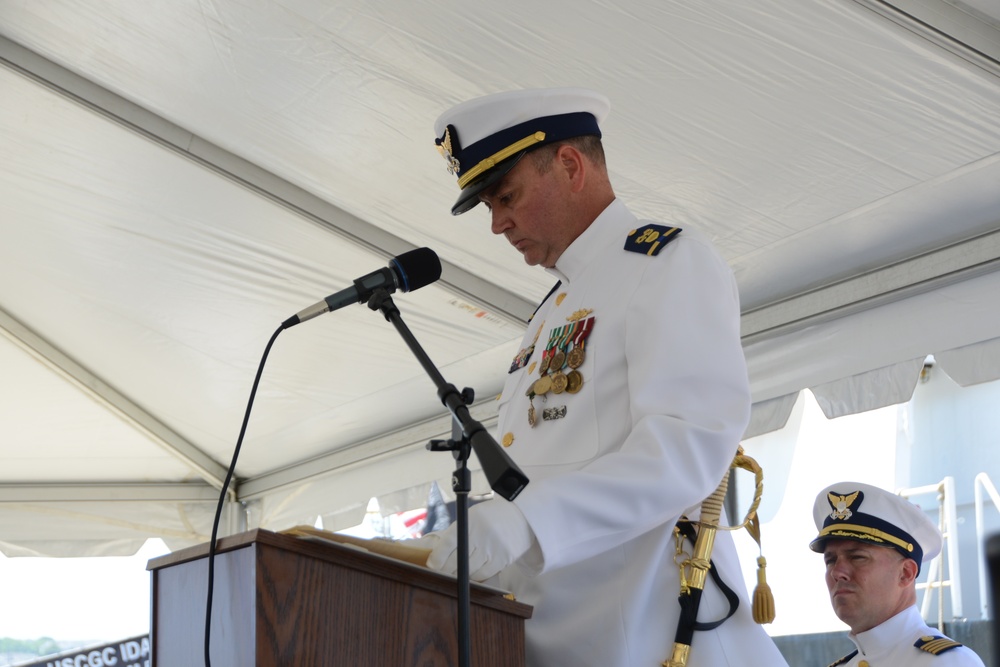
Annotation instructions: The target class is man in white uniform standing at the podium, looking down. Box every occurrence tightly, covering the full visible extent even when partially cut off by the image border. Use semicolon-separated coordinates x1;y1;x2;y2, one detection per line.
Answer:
418;89;786;667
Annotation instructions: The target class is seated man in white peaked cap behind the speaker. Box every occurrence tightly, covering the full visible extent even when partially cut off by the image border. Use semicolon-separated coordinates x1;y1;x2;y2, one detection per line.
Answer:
809;482;983;667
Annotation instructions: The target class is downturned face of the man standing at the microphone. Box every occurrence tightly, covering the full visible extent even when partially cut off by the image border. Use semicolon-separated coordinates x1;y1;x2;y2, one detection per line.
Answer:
480;154;581;267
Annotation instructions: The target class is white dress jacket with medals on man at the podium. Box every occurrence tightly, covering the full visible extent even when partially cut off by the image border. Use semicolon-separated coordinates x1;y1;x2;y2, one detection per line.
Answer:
498;200;786;667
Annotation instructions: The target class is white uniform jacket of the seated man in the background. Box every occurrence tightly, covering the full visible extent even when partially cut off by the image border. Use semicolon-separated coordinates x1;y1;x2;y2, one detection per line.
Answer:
831;606;983;667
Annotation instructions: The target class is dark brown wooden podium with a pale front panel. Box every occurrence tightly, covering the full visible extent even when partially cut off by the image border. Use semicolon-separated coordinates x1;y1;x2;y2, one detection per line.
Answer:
147;530;531;667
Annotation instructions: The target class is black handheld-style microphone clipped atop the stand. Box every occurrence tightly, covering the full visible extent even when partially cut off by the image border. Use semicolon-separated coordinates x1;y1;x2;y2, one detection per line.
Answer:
281;248;441;329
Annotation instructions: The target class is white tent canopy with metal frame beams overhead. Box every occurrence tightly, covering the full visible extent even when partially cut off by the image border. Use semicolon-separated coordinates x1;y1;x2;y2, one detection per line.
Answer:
0;0;1000;555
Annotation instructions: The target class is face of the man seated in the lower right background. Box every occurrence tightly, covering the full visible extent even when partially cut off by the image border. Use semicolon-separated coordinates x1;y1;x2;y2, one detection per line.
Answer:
823;540;917;634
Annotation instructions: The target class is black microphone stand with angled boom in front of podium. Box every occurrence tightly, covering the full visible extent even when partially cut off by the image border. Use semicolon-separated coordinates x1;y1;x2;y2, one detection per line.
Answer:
368;288;528;667
